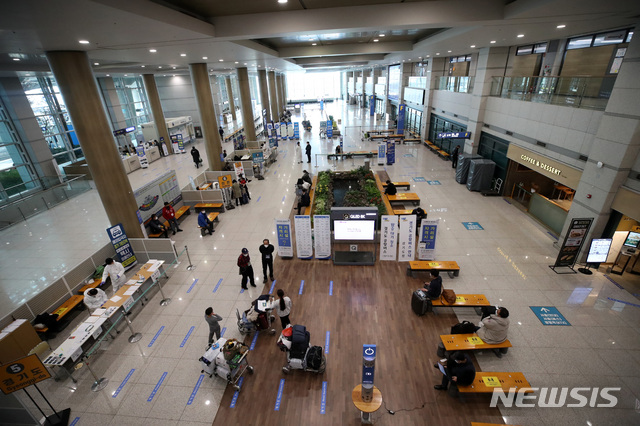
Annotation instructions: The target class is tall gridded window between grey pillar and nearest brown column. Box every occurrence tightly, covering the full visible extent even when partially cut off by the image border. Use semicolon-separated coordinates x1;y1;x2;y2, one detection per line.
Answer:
20;77;84;171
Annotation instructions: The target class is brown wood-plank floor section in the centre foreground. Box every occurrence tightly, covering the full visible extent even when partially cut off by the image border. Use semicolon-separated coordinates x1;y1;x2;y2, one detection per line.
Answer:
213;241;503;426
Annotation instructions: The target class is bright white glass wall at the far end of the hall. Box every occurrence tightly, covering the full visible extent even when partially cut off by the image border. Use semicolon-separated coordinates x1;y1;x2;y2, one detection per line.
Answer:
287;72;340;102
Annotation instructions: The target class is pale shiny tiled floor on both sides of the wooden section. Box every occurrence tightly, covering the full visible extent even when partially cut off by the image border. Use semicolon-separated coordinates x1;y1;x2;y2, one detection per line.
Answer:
0;104;640;426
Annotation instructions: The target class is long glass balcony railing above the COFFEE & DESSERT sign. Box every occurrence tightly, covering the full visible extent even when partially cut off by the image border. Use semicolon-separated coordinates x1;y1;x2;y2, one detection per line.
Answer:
490;76;616;110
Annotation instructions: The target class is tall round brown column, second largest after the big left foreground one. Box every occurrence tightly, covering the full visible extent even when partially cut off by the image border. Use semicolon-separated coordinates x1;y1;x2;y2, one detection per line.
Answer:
189;63;222;170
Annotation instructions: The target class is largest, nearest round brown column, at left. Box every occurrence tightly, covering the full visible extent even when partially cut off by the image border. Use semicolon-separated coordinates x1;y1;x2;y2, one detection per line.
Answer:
47;51;144;238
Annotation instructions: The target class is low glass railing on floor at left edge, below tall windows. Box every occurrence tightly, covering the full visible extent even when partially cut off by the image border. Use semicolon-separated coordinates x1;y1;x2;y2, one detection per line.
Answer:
0;175;91;230
